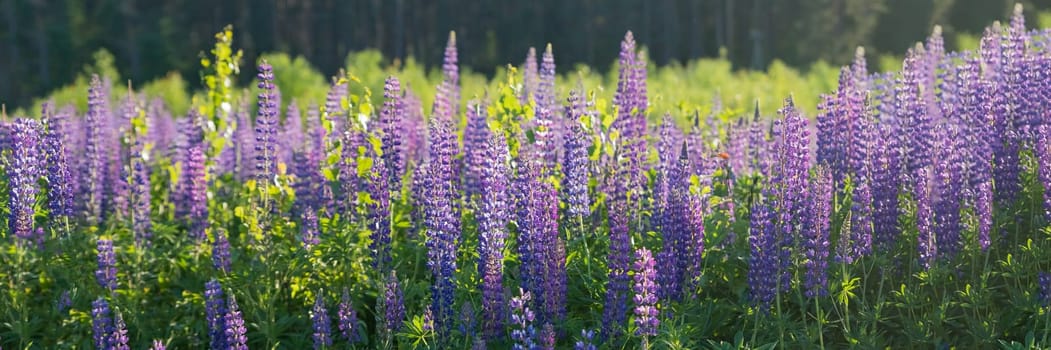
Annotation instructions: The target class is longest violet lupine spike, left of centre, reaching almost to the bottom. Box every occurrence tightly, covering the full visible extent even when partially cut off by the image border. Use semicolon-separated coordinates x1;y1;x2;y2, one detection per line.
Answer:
423;112;460;335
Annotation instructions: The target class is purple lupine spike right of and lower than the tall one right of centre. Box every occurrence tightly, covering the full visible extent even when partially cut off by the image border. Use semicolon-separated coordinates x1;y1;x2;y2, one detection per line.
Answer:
801;165;834;297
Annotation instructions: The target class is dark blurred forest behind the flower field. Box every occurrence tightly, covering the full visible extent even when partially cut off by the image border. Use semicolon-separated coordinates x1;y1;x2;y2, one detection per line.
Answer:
0;0;1051;107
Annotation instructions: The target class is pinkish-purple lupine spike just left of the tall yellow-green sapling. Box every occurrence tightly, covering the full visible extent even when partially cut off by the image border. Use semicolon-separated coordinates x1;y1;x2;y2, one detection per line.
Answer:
179;145;208;241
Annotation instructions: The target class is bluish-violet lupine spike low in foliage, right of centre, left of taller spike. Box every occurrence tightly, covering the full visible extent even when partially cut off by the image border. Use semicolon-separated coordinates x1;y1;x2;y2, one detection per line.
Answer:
748;203;780;313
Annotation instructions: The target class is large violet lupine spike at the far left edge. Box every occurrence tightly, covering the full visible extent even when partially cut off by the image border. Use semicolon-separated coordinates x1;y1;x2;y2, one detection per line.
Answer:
7;118;43;243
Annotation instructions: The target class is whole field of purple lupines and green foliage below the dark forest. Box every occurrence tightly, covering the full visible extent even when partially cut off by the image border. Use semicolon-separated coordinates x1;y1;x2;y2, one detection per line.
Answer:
10;6;1051;350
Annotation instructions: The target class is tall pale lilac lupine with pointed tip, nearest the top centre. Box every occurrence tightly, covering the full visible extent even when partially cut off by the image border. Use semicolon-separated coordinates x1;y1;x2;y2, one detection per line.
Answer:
534;44;560;169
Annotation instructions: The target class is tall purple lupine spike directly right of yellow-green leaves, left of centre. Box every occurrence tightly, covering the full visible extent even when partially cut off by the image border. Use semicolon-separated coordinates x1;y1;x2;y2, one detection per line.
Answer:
379;76;406;190
